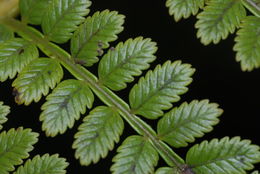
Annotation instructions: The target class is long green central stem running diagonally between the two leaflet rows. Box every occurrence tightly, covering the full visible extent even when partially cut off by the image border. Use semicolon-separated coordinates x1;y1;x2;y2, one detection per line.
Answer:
0;18;185;169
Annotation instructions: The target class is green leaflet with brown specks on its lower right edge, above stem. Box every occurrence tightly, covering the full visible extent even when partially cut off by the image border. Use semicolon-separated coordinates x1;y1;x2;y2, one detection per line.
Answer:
71;10;124;66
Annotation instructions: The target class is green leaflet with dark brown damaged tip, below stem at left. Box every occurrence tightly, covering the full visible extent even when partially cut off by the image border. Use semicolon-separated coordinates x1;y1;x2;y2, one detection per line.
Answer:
12;58;63;105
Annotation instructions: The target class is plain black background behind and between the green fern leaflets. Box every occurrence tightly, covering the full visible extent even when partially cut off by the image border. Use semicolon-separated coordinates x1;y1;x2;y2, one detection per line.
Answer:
0;0;260;174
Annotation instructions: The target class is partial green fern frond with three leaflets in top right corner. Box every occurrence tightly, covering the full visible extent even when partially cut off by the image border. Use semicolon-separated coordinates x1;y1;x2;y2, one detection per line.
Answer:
166;0;260;71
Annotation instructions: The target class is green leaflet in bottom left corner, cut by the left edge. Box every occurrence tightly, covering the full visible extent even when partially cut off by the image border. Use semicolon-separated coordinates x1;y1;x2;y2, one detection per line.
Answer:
0;127;38;174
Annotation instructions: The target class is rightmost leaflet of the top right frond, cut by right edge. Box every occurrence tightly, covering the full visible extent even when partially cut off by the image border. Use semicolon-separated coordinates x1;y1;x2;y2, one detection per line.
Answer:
234;16;260;71
